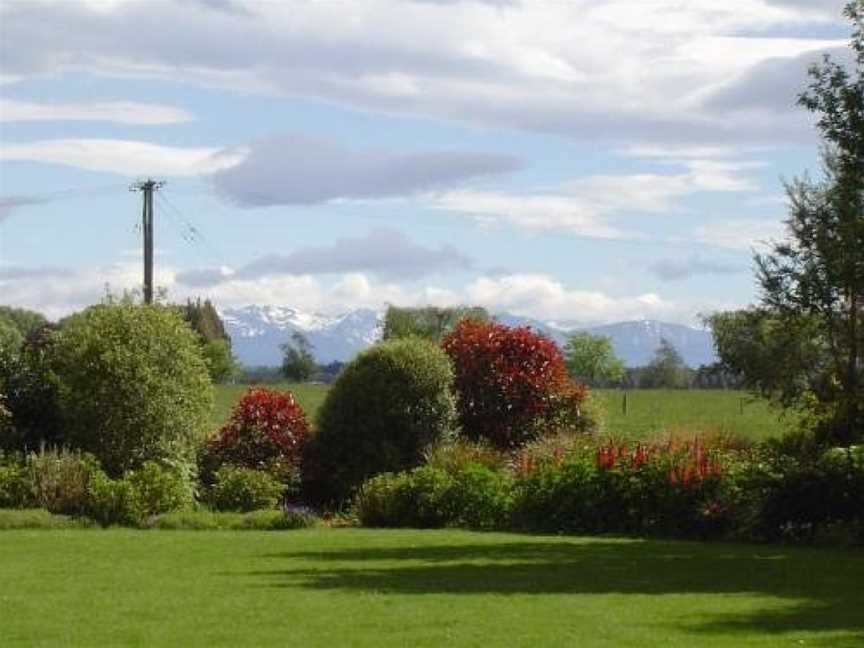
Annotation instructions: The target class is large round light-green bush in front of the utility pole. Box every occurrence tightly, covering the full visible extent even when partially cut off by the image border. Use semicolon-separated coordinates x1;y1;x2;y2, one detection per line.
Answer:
50;303;213;477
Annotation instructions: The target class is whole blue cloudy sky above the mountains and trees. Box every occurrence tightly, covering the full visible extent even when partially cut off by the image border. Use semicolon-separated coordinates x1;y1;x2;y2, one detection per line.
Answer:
0;0;851;325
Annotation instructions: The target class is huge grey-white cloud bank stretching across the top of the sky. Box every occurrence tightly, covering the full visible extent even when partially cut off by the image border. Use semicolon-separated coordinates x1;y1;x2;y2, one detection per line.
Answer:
0;0;837;143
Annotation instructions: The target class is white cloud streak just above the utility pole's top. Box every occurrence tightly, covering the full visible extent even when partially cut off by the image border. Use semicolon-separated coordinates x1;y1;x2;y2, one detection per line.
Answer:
0;139;242;176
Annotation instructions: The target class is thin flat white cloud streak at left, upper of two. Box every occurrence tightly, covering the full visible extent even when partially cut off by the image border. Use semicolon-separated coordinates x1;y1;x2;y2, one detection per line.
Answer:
0;99;192;125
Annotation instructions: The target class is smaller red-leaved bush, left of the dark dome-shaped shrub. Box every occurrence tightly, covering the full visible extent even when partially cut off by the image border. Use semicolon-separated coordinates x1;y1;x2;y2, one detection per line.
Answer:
202;389;309;486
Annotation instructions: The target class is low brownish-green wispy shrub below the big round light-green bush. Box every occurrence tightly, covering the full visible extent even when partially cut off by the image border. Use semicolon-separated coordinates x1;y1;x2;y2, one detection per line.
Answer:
25;448;99;515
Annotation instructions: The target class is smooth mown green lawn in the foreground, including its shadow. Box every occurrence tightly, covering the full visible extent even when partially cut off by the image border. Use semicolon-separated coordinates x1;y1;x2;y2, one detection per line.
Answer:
0;529;864;648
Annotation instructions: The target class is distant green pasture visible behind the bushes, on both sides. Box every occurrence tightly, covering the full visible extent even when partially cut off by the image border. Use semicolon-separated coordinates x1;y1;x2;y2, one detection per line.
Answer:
213;383;794;440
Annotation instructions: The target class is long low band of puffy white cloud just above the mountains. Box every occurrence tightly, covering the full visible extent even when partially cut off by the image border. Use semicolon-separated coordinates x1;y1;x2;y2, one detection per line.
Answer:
0;263;736;324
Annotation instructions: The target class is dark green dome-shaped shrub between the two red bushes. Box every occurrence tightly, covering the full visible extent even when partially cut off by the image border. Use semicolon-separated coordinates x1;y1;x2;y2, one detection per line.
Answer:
304;338;456;503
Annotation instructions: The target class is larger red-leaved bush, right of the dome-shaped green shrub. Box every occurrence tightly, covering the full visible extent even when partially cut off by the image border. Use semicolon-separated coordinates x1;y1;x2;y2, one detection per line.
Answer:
442;319;586;449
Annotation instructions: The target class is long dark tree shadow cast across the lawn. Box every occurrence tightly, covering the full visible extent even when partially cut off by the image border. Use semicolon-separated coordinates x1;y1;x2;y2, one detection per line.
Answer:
249;538;864;648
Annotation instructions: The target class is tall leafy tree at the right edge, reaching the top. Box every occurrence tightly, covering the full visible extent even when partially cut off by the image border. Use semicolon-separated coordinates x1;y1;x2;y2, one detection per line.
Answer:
718;0;864;444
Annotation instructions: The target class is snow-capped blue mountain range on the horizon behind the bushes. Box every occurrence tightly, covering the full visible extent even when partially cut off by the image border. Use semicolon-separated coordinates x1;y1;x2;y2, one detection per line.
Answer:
219;305;716;367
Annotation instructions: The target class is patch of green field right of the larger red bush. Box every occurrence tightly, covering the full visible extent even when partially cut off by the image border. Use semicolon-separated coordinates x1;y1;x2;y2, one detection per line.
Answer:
592;389;796;441
